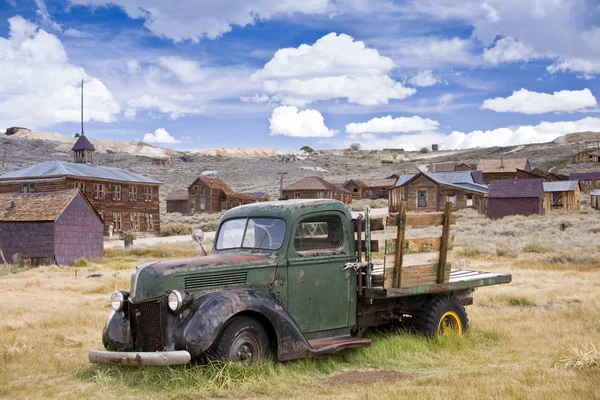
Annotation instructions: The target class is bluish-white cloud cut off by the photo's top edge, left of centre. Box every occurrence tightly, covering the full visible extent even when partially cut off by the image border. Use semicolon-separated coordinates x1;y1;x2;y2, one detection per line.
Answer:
71;0;333;42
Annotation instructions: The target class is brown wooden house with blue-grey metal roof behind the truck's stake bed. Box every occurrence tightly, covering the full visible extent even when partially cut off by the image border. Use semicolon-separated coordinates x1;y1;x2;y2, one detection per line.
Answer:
388;171;488;212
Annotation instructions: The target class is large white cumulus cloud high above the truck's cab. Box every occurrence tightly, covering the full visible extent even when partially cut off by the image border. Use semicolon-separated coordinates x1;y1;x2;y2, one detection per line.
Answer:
252;33;416;106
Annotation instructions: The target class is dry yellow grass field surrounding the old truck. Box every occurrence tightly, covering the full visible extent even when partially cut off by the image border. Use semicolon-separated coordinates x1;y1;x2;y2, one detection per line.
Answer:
0;209;600;399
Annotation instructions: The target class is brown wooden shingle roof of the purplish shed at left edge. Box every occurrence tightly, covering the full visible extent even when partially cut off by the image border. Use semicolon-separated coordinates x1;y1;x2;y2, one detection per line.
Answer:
0;189;100;222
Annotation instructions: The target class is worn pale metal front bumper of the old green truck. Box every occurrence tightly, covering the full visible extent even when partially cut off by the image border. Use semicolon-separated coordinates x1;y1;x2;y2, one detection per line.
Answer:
88;350;192;366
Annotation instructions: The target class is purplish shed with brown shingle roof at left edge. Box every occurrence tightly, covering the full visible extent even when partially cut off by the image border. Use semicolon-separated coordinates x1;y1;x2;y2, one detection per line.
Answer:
0;189;104;266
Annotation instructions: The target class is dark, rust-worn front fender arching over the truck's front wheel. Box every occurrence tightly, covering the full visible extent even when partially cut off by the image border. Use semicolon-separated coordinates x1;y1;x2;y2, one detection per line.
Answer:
173;289;310;361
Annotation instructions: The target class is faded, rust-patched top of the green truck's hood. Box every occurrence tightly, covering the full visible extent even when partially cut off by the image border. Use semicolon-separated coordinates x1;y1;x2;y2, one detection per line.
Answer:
131;253;277;302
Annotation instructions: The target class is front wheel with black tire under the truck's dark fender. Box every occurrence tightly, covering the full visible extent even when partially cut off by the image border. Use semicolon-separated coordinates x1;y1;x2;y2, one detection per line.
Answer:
210;317;270;367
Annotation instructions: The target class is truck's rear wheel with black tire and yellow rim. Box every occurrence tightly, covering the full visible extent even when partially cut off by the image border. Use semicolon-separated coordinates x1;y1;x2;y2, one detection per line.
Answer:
414;296;469;337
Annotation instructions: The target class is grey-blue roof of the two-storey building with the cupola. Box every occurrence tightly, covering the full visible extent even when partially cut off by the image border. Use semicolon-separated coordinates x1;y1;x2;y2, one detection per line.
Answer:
0;161;161;185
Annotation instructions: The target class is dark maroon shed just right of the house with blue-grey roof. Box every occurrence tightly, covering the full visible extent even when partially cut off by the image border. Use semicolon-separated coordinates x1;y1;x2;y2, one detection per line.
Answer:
484;179;544;219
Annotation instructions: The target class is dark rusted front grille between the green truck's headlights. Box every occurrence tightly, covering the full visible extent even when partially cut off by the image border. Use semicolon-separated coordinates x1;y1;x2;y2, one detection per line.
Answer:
129;298;165;351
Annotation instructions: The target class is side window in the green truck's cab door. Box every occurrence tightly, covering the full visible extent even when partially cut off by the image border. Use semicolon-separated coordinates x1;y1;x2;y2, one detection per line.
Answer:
294;215;344;252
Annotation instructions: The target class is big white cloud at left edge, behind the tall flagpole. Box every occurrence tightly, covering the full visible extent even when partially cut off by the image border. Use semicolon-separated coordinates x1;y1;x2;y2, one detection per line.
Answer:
0;16;121;128
